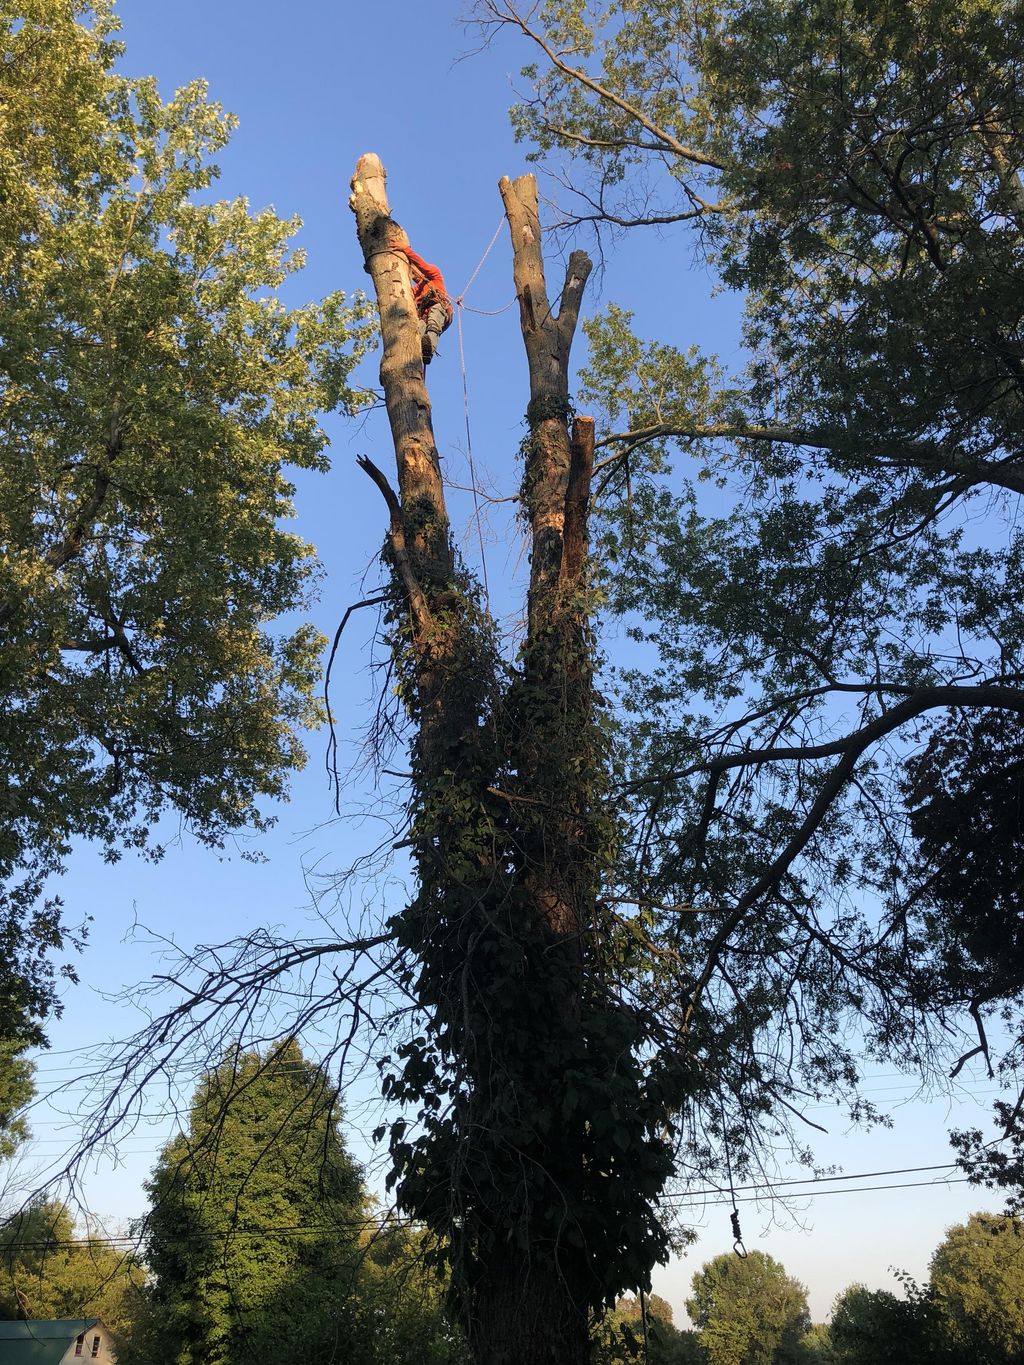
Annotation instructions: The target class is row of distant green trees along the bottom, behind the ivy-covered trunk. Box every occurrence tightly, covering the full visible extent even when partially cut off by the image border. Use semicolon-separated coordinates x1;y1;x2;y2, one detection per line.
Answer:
0;1040;1024;1365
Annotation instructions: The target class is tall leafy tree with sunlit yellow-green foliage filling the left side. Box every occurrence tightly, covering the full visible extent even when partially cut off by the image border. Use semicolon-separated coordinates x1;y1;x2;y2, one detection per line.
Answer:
0;0;366;1037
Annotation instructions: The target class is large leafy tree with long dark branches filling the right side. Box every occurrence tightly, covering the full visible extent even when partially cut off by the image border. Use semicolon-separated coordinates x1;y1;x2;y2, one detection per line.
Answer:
494;0;1024;1177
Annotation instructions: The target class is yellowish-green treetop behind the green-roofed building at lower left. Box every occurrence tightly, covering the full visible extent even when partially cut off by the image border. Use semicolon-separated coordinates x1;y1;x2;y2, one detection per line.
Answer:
0;1198;143;1334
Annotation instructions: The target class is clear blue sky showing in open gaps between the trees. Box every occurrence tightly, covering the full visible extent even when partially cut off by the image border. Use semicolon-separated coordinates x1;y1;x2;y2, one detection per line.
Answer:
10;0;998;1320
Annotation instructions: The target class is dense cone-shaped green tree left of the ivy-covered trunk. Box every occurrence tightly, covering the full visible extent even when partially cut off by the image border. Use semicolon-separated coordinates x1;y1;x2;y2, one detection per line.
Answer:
143;1043;365;1365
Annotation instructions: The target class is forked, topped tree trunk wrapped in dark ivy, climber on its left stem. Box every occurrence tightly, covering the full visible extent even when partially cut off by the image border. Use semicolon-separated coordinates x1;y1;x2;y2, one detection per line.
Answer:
351;156;677;1365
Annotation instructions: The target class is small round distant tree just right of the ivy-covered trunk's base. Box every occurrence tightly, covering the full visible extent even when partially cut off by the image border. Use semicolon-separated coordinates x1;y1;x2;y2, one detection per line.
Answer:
687;1252;811;1365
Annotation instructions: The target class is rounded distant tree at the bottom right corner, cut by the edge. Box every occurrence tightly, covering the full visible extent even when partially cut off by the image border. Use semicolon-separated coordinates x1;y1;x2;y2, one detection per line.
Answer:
930;1213;1024;1365
